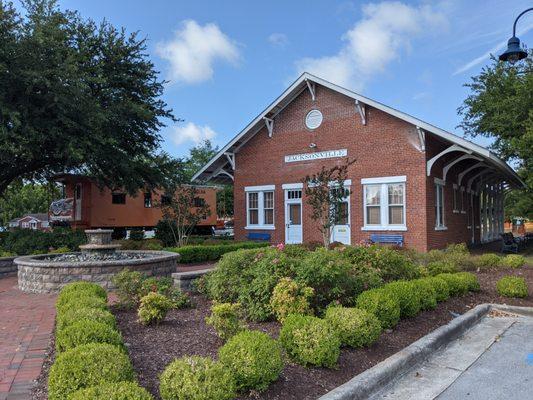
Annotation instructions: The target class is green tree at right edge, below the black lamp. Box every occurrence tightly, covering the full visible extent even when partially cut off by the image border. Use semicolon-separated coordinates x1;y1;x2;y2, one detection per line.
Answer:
458;51;533;218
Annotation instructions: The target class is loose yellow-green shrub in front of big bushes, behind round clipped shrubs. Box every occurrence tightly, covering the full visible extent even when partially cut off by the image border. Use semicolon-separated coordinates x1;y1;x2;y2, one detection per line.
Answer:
270;278;315;322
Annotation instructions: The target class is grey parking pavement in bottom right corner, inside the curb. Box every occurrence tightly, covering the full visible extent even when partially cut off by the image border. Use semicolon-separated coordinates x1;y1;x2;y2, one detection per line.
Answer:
372;316;533;400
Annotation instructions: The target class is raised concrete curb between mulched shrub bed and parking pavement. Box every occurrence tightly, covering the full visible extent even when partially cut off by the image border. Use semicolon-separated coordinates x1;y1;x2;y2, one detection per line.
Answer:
319;304;490;400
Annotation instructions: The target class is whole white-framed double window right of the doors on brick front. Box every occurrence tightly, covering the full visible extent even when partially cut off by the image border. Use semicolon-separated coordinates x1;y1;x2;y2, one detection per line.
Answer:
362;176;406;230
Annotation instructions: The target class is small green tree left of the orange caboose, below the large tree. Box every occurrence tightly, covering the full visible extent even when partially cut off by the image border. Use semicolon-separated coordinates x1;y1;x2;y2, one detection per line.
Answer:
0;181;60;226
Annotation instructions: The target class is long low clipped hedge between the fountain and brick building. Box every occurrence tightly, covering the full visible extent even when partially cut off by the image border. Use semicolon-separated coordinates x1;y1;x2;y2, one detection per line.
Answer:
165;242;270;264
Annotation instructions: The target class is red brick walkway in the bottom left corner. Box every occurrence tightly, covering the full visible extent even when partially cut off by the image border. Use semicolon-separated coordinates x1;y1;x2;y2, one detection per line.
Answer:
0;277;55;400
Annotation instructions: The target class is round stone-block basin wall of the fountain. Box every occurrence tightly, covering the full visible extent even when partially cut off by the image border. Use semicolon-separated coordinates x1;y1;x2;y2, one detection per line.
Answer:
15;250;179;293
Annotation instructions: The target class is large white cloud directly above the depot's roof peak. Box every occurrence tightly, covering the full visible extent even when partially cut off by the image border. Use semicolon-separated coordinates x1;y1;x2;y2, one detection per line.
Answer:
296;1;448;90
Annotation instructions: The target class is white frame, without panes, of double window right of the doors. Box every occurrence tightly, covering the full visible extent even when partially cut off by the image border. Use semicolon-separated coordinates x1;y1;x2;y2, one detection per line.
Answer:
361;175;407;231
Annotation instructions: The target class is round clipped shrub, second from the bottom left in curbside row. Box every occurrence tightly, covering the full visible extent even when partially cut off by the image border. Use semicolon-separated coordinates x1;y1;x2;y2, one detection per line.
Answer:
218;330;283;391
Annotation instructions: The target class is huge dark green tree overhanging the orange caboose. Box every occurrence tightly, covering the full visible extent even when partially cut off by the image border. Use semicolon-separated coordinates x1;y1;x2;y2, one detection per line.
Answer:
0;0;176;194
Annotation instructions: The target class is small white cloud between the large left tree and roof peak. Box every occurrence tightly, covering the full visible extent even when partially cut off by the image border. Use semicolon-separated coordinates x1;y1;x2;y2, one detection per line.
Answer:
156;20;240;83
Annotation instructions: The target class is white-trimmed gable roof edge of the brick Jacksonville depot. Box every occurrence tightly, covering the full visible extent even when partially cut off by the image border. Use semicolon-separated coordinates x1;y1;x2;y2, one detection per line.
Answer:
192;72;525;187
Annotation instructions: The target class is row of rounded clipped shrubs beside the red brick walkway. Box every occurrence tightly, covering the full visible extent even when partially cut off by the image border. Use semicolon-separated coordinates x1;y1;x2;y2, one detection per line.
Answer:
48;282;152;400
